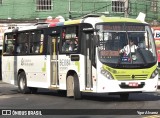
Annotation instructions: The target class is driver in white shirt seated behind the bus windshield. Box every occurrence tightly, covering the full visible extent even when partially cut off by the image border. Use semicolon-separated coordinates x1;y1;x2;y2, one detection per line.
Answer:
120;39;138;55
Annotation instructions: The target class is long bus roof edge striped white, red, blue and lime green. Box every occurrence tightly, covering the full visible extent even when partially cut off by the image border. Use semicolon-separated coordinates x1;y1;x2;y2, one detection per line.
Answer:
5;16;147;33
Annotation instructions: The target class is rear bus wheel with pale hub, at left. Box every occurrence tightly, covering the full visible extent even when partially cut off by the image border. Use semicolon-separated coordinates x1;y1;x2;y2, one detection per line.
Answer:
18;72;30;94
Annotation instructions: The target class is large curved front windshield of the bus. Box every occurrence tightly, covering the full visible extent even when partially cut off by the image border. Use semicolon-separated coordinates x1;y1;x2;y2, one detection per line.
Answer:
96;23;157;68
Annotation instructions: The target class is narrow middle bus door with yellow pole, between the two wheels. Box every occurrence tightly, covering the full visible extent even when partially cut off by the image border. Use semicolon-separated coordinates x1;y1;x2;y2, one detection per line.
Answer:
50;36;59;87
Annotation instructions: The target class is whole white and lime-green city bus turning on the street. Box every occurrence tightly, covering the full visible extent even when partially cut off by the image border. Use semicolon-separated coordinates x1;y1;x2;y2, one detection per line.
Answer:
2;16;158;100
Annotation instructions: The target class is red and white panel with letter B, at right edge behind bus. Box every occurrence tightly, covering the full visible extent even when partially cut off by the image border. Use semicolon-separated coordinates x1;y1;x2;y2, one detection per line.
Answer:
152;27;160;67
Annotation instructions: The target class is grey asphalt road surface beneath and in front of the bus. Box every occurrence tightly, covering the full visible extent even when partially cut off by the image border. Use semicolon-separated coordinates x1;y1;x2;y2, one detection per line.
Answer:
0;81;160;118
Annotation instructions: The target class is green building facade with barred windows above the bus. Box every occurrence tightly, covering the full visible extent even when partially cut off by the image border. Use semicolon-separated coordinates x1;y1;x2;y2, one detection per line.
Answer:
0;0;160;23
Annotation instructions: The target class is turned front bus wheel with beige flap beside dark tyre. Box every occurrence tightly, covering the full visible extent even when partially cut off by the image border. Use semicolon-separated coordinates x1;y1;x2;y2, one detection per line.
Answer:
67;74;81;100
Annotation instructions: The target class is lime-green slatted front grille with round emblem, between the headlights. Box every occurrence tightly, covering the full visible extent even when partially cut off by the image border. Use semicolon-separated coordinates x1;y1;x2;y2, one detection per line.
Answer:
115;74;148;81
